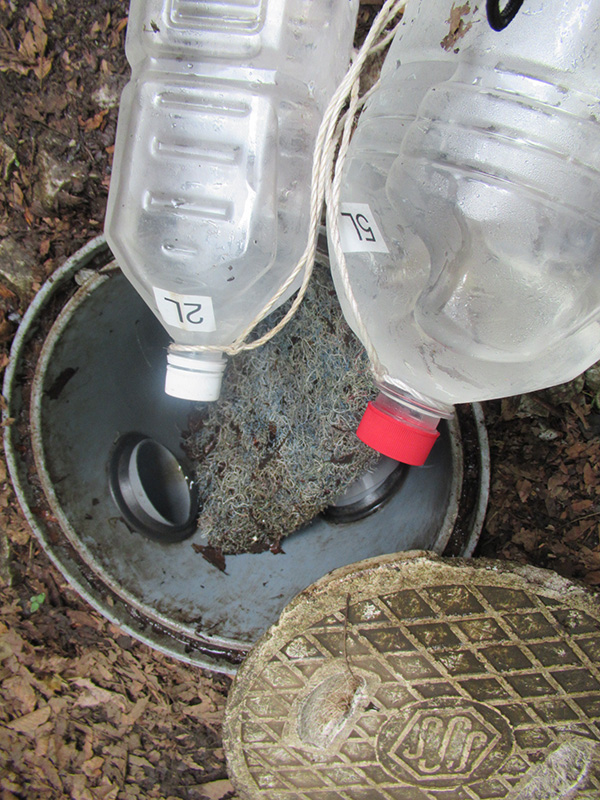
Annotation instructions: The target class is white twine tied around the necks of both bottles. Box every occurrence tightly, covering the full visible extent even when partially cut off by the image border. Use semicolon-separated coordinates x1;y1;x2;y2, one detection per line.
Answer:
170;0;406;358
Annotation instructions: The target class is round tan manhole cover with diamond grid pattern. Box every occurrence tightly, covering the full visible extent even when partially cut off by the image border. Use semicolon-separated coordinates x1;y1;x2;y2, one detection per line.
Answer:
224;553;600;800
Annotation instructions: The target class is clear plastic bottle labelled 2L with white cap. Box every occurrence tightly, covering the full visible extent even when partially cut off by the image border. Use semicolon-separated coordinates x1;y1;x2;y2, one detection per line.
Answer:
105;0;358;400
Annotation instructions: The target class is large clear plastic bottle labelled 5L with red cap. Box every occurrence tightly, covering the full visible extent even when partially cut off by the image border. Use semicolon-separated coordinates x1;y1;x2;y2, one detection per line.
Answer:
330;0;600;463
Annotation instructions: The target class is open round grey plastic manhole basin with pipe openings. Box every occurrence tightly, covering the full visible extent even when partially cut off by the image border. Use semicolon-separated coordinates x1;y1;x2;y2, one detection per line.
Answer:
4;238;489;672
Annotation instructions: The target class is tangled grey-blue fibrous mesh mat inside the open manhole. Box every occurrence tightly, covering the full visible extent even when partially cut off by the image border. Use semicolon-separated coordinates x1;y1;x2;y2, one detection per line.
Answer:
185;264;378;553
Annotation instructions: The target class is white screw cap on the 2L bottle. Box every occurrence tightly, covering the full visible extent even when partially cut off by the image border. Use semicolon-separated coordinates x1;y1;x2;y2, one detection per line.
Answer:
165;353;227;403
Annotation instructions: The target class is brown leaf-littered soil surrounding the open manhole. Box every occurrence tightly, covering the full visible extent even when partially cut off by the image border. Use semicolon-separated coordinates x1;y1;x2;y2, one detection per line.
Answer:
0;0;600;800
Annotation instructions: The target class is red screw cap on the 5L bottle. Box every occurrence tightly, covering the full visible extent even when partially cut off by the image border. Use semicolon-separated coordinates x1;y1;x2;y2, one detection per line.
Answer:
356;403;439;467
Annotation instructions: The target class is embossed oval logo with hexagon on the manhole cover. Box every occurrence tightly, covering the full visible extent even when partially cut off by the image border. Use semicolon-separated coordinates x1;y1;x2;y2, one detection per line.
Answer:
377;698;513;789
